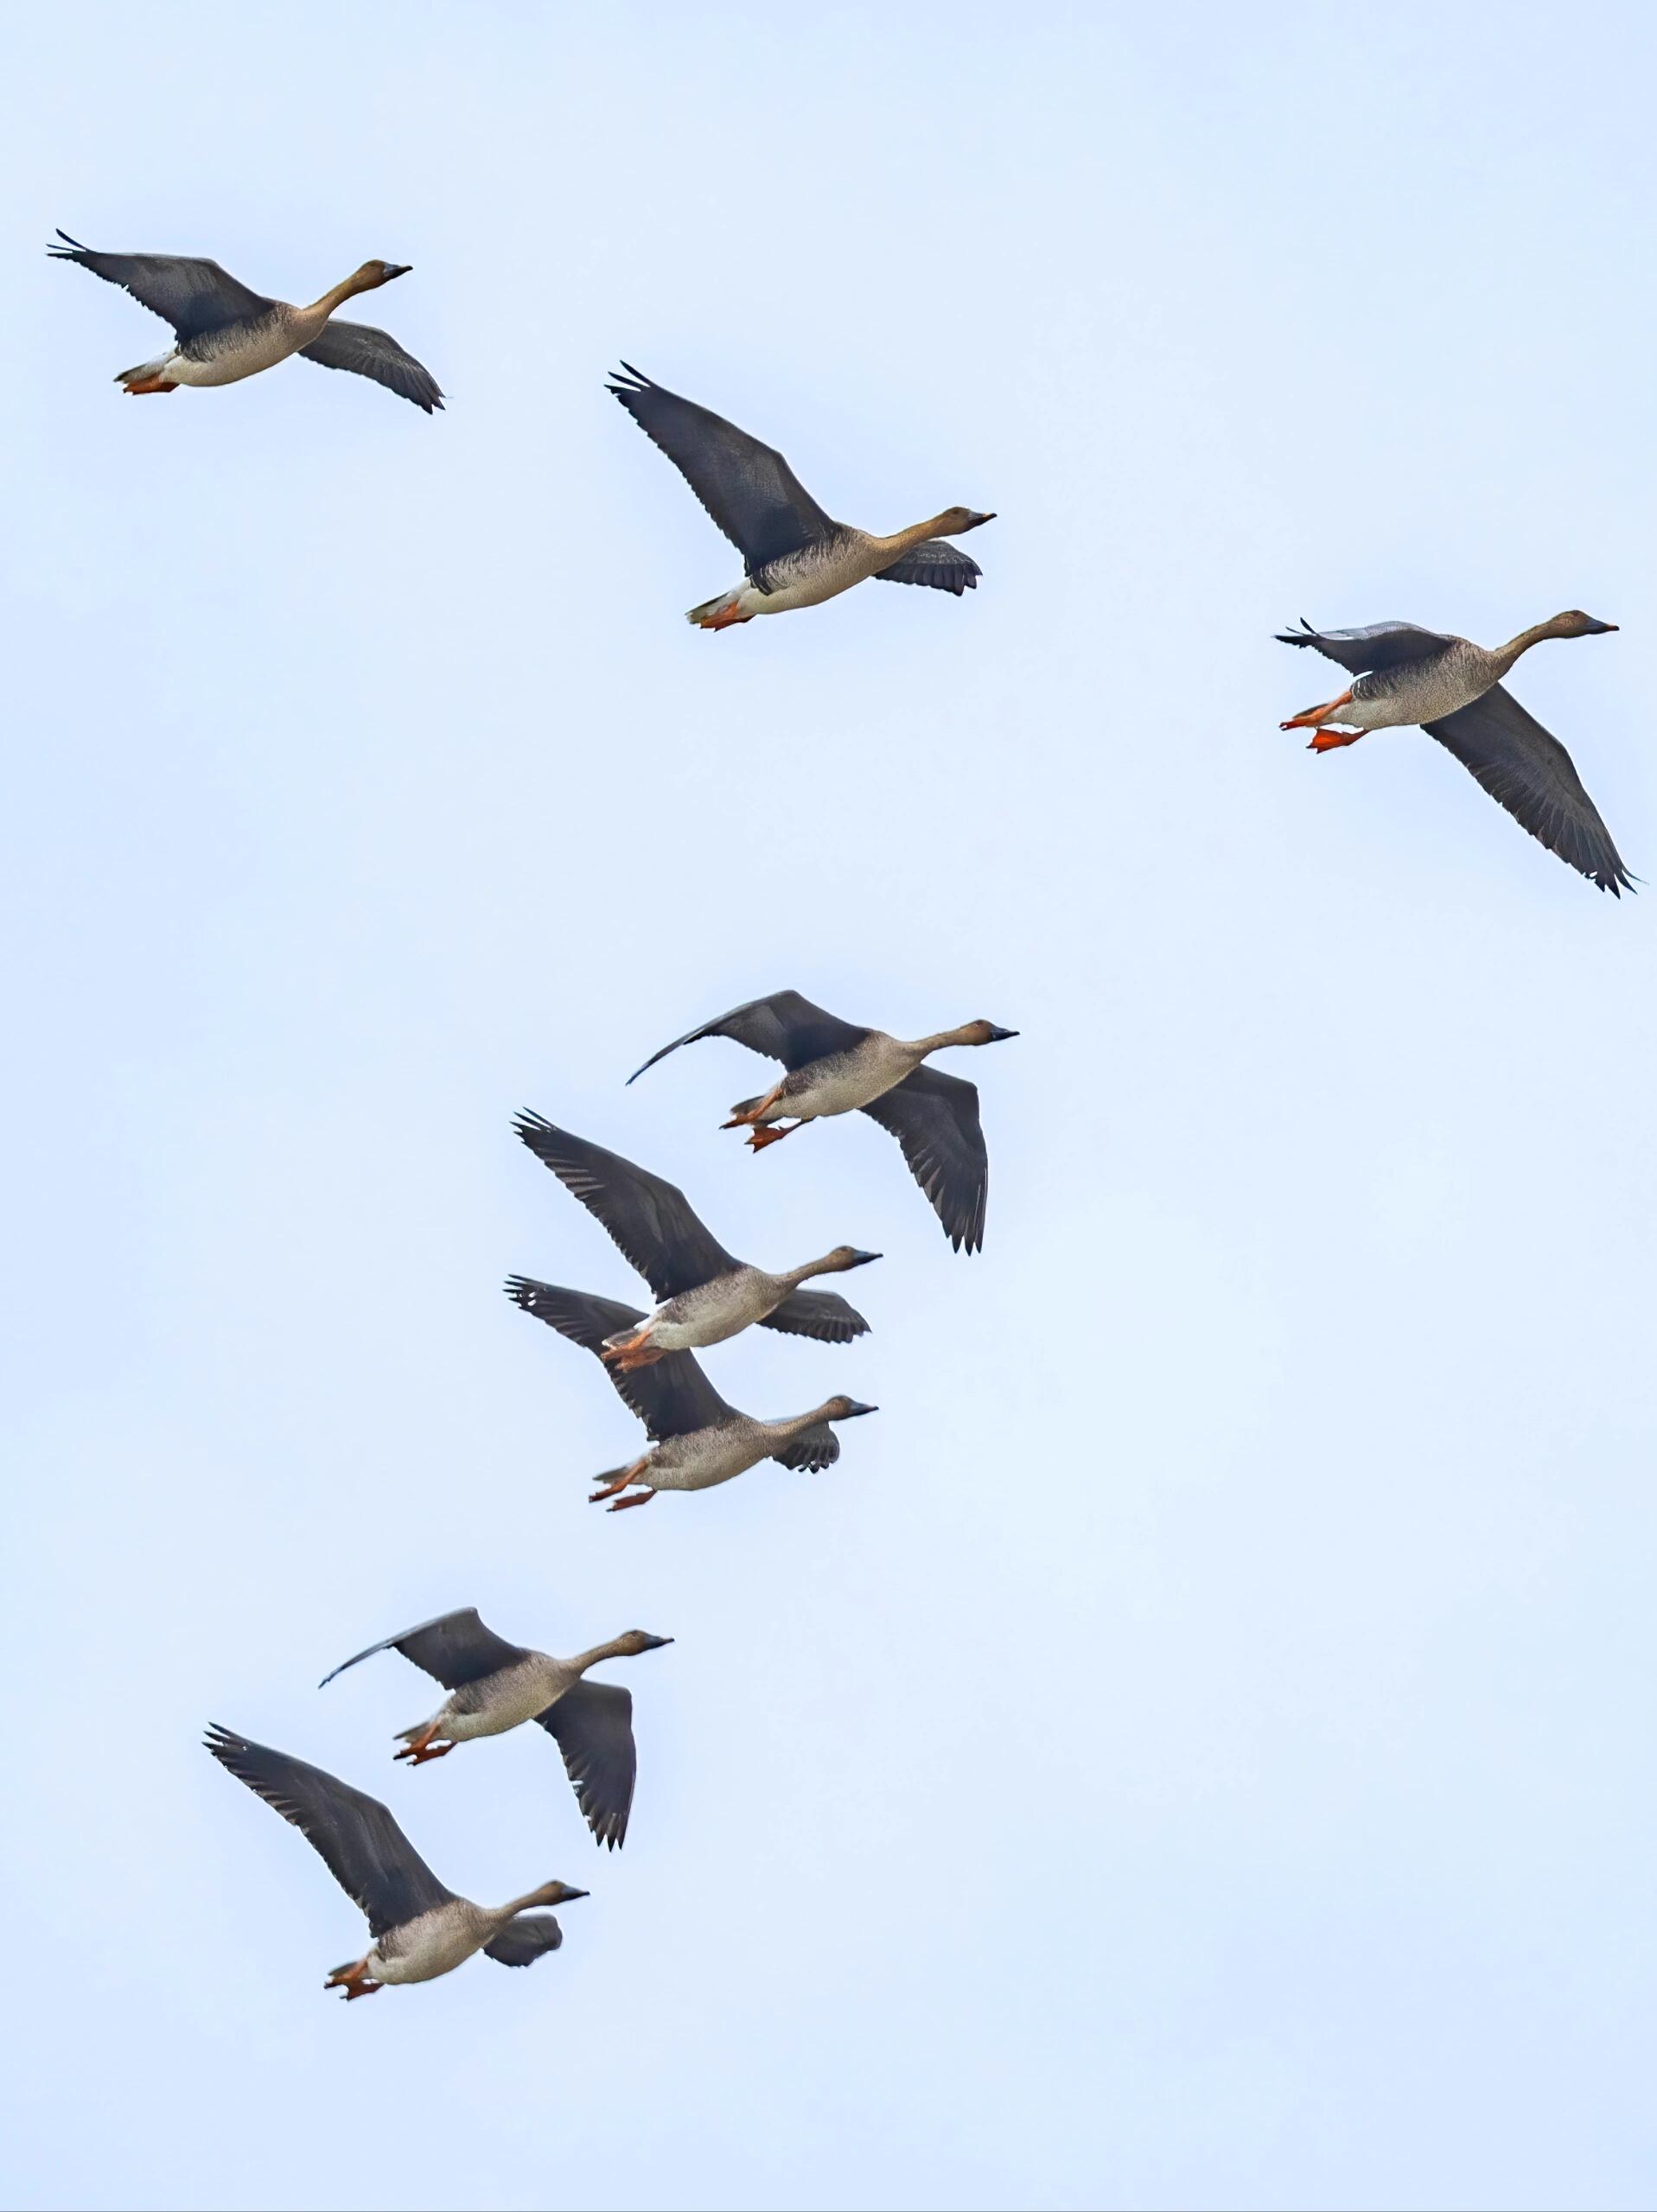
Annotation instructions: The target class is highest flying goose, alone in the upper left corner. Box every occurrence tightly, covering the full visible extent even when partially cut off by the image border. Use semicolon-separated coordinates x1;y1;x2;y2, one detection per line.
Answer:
47;230;443;414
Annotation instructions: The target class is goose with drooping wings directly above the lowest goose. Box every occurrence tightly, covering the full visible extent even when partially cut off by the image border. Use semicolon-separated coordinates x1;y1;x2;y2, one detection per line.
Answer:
316;1606;672;1849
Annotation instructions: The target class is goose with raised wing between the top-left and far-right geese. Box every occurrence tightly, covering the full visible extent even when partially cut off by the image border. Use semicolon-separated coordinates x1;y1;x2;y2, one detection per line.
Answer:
604;360;996;630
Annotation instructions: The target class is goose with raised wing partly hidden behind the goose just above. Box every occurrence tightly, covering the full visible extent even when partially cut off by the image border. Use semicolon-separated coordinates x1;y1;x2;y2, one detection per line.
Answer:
507;1274;881;1513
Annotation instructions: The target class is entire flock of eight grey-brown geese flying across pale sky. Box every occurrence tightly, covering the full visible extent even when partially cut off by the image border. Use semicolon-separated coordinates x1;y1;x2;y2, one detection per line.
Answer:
47;230;1635;2002
